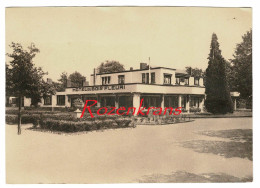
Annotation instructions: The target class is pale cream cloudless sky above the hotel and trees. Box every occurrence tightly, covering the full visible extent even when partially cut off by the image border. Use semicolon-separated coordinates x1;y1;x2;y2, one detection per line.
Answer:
6;7;252;81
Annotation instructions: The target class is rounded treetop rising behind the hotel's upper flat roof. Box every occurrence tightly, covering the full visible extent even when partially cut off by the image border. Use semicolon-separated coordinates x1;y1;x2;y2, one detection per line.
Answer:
97;60;125;74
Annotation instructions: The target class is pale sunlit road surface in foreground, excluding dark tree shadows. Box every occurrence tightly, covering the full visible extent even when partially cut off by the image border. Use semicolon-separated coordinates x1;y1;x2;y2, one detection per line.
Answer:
6;118;252;183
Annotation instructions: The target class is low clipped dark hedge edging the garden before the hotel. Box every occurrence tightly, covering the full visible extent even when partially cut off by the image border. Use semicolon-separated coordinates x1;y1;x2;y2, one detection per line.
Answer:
5;113;135;132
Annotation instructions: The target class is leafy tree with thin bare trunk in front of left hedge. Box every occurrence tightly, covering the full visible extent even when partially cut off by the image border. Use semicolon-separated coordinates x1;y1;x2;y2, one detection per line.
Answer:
6;43;52;134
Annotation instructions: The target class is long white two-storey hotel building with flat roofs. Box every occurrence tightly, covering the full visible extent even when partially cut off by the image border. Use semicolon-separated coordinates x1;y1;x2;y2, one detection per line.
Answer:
25;63;205;112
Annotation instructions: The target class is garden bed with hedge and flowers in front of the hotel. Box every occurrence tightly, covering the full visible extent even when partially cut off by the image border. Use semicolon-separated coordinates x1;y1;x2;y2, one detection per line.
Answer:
5;107;192;133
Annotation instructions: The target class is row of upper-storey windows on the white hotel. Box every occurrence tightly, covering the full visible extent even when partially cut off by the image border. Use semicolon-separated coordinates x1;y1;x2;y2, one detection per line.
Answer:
102;72;199;85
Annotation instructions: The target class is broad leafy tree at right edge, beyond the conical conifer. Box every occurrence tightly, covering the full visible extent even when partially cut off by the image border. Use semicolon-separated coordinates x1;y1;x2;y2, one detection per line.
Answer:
231;29;252;99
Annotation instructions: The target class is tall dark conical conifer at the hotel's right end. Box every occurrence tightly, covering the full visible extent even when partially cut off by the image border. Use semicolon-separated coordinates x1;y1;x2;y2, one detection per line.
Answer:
205;33;233;114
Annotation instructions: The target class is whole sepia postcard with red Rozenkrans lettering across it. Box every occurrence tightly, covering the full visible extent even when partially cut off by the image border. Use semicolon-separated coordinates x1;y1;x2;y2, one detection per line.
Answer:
5;6;253;184
